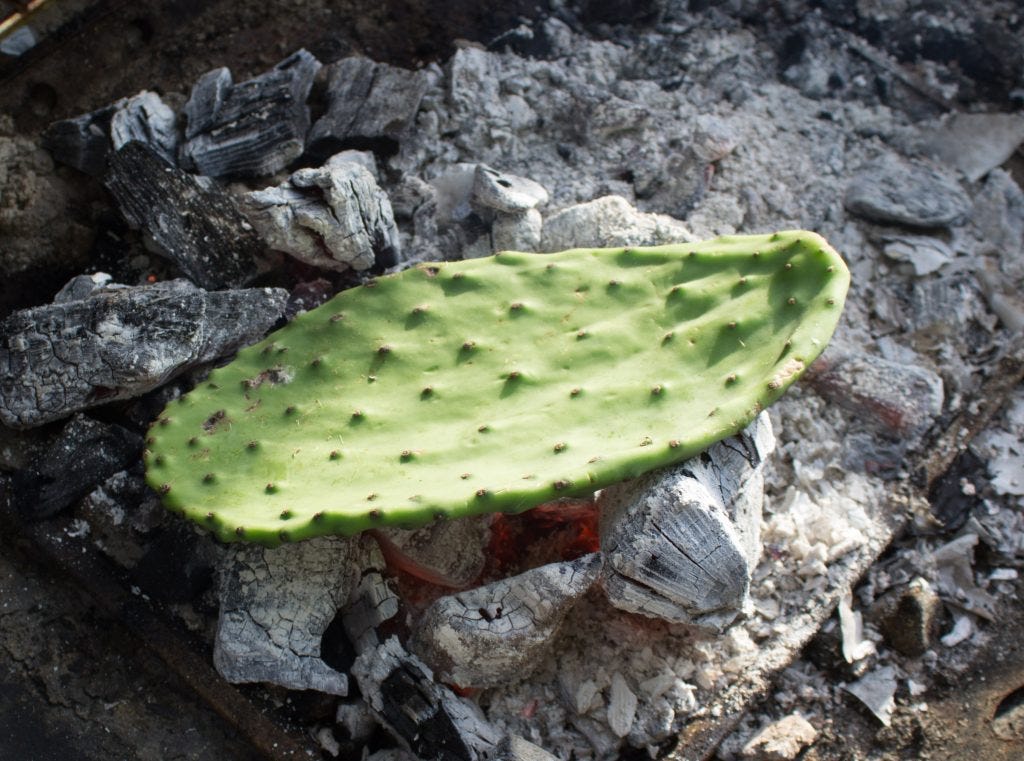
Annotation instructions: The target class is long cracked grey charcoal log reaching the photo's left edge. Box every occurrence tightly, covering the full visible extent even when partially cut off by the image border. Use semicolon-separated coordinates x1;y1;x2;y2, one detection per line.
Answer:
0;280;288;428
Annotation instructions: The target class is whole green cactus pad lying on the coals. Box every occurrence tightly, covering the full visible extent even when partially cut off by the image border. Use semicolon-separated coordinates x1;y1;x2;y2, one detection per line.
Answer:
145;231;849;545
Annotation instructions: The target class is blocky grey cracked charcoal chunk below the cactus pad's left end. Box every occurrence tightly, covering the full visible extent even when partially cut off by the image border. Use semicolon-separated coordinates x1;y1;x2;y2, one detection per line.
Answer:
213;537;359;695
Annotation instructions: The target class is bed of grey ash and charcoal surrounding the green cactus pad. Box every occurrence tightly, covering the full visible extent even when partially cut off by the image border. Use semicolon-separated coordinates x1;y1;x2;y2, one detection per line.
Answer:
0;2;1024;759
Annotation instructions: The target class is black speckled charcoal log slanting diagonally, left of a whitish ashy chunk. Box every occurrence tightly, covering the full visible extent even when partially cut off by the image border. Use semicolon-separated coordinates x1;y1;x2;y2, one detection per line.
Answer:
104;142;263;289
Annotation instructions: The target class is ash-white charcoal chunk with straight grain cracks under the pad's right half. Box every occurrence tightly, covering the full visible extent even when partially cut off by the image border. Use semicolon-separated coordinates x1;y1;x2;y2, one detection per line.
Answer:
598;413;775;630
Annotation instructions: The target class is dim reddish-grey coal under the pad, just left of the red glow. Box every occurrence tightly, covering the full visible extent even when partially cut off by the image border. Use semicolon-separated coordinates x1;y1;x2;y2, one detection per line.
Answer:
374;515;493;589
